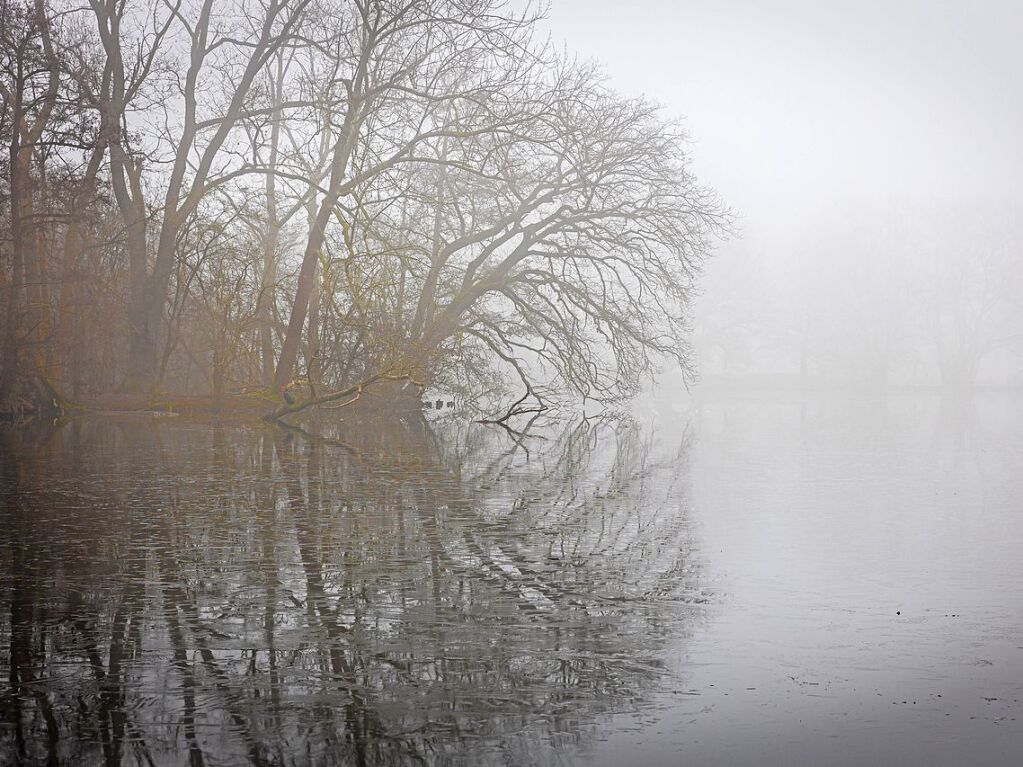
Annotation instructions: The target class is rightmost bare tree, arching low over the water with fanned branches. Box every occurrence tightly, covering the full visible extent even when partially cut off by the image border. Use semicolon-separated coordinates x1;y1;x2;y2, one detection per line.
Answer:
413;69;728;409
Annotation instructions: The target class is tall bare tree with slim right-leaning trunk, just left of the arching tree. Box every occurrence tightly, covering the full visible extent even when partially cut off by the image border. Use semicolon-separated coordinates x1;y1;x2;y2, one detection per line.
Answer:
274;0;544;387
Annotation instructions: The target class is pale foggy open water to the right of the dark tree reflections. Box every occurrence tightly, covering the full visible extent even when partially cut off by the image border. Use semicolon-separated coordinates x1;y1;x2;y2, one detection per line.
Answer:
594;394;1023;766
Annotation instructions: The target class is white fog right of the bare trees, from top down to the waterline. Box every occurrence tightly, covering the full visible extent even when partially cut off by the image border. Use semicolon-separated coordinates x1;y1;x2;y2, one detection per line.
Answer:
549;0;1023;388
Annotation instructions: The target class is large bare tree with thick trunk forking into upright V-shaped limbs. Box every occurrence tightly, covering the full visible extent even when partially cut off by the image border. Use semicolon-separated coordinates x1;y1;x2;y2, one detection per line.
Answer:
91;0;309;391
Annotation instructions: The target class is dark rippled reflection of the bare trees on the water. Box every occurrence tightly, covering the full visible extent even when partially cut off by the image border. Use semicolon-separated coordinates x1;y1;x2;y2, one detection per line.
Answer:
0;418;700;765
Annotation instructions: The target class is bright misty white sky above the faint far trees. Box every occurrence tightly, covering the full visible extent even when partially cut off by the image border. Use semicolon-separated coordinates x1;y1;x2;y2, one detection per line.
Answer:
548;0;1023;239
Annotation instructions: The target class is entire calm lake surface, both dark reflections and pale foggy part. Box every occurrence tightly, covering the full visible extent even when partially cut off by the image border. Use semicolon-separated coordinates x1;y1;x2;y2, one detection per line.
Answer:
0;396;1023;765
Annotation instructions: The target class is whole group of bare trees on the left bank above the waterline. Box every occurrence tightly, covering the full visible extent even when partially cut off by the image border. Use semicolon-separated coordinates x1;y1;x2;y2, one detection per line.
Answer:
0;0;729;421
